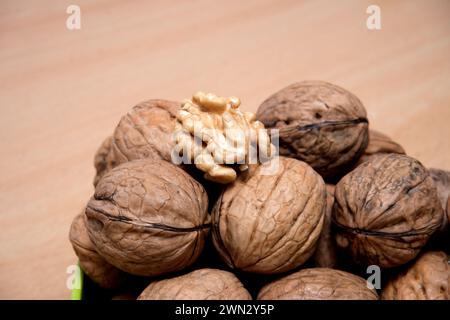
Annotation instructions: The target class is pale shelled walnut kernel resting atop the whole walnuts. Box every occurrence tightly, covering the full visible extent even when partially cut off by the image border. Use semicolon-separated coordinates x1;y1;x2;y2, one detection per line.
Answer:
172;92;275;184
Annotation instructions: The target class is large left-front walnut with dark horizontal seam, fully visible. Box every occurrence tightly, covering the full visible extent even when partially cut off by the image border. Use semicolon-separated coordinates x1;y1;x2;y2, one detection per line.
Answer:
86;159;210;276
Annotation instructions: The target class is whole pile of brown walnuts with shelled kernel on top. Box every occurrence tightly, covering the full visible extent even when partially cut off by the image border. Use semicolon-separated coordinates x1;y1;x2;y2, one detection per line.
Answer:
70;81;450;300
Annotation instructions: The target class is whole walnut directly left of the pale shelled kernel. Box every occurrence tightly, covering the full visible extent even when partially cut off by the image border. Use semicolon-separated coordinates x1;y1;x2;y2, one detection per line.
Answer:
111;99;181;166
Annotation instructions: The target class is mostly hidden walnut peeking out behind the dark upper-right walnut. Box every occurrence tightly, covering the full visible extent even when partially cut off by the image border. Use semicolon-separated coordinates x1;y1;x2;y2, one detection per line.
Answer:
357;129;406;165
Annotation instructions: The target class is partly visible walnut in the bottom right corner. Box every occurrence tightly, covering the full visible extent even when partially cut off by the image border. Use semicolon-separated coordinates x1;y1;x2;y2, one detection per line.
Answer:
381;251;450;300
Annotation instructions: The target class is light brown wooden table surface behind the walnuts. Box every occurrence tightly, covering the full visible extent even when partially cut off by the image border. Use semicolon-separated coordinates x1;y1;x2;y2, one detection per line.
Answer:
0;0;450;299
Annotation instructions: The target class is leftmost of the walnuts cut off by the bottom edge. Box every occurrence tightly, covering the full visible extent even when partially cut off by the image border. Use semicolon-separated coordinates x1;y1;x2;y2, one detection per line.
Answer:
138;269;252;300
